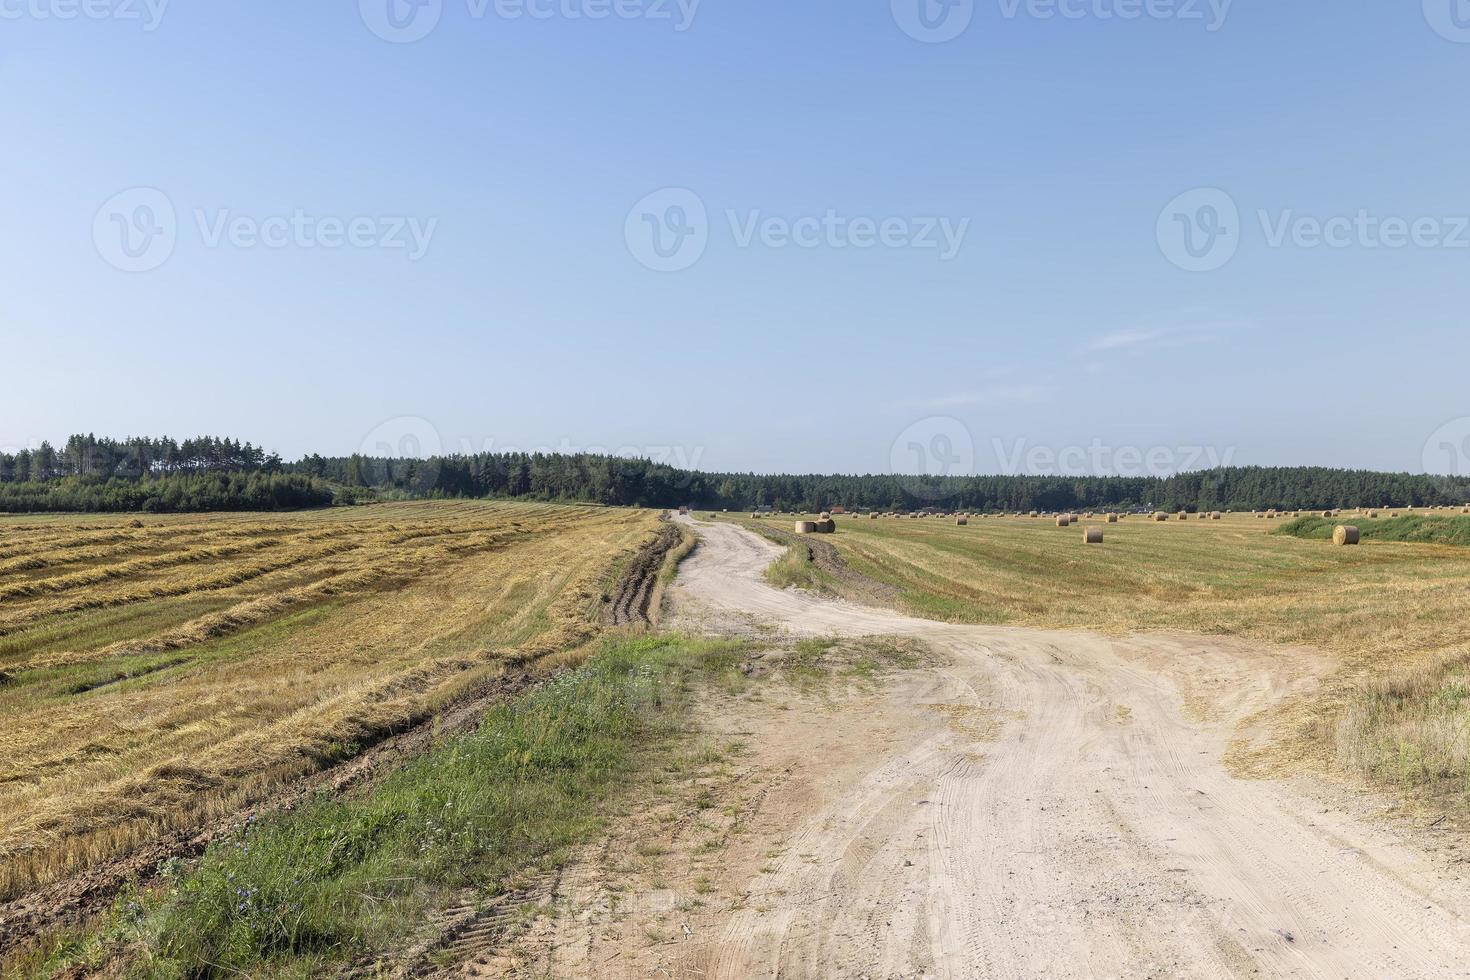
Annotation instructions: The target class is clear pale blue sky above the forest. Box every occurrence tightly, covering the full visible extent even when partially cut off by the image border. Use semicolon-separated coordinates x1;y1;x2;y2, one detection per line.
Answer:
0;0;1470;472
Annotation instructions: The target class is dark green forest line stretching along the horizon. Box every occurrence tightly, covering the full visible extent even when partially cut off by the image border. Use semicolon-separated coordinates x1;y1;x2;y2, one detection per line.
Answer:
0;435;1470;513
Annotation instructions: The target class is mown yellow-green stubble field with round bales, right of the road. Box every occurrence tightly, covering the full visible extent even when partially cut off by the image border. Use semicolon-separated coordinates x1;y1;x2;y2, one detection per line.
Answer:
750;514;1470;790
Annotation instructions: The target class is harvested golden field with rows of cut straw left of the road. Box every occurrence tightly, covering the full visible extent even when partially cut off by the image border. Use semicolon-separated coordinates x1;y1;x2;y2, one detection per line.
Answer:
0;502;656;895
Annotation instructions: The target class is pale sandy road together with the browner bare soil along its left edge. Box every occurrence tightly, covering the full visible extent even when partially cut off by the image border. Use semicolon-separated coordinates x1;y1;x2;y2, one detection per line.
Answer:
452;523;1470;979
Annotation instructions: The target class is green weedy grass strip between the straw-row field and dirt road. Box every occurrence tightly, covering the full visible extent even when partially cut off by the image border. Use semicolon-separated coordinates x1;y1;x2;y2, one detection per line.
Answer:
32;636;744;979
